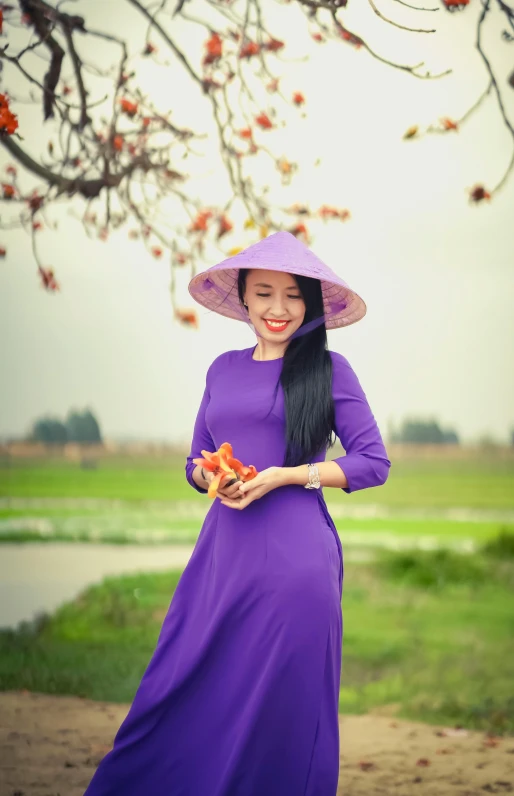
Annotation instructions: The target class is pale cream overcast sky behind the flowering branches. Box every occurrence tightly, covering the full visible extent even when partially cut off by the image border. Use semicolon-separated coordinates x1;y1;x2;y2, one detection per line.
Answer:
0;0;514;443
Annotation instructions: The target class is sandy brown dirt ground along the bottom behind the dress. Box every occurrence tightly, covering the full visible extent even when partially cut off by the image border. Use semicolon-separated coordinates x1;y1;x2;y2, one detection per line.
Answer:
0;691;514;796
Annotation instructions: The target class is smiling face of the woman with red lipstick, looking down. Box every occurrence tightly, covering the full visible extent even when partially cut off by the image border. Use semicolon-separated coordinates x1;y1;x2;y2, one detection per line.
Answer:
244;268;305;343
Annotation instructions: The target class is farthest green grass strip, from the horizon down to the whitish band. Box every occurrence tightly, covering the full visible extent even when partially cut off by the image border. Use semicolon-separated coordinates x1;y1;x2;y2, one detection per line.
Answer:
0;449;514;510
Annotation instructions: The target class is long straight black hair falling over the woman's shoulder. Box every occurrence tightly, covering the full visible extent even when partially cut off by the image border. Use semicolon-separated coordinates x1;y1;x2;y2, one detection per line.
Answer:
237;268;336;467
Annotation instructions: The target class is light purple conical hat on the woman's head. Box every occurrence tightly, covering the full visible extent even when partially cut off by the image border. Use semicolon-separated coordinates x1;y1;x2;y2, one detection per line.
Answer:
188;231;366;336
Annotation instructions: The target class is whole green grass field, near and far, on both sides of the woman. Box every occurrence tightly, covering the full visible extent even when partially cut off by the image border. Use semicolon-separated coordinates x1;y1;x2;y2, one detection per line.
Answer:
0;451;514;733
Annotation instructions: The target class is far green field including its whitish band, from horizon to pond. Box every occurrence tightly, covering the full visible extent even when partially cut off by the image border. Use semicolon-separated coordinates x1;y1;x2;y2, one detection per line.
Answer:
0;451;514;547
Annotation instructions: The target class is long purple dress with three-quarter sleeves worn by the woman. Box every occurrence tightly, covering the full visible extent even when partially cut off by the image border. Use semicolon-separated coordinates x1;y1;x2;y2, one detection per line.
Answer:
86;347;391;796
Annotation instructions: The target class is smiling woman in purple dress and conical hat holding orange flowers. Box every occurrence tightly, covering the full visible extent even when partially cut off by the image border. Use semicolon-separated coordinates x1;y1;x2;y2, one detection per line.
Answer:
86;232;391;796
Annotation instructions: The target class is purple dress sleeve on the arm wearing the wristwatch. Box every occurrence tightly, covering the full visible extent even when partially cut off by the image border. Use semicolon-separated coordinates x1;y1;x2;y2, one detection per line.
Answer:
332;352;391;493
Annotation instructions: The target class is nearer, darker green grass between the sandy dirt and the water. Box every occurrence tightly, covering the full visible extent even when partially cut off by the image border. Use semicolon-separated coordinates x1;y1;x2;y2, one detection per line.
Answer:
0;537;514;733
